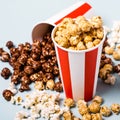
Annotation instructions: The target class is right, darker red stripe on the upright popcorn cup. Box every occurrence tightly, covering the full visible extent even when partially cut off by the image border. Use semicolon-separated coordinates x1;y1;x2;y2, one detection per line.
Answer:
84;48;98;101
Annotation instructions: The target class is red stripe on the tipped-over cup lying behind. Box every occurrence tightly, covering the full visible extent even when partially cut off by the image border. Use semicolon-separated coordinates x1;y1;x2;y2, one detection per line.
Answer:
55;3;92;24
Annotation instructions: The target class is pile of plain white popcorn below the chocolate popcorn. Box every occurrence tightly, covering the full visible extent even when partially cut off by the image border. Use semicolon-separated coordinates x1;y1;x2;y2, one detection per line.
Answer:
13;90;66;120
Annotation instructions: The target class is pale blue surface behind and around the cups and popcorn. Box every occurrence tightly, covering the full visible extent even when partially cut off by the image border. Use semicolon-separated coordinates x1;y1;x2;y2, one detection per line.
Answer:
0;0;120;120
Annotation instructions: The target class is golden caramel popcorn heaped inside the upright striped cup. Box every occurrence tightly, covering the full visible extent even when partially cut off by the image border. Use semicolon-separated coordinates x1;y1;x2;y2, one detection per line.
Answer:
54;16;104;50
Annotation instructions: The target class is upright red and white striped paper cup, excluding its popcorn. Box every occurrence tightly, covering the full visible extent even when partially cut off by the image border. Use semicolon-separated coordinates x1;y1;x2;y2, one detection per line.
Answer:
52;27;106;101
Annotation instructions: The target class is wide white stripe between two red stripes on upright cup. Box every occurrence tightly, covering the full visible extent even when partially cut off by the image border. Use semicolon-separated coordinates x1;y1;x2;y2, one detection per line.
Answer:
68;52;85;100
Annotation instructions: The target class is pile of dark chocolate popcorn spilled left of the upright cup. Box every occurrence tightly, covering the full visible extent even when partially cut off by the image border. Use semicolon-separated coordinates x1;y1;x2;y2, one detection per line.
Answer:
0;33;63;101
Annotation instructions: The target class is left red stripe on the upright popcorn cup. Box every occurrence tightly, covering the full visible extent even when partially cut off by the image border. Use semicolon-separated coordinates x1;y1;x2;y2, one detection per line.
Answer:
57;47;73;98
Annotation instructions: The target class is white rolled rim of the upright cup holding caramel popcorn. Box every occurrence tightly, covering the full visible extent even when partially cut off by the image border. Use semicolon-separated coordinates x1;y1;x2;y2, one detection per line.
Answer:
51;25;107;53
